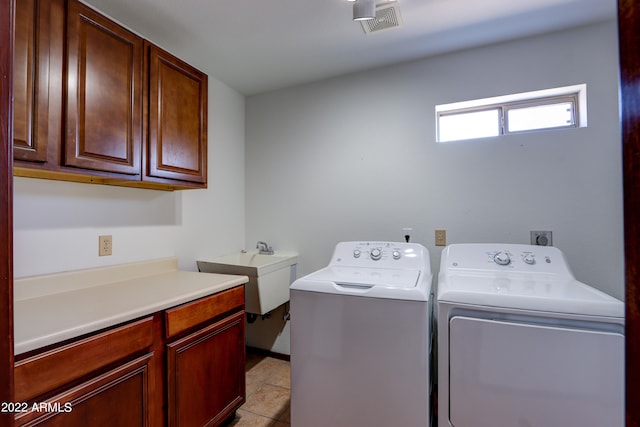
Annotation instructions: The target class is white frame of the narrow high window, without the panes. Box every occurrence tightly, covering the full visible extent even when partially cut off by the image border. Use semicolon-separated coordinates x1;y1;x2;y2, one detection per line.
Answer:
436;84;587;143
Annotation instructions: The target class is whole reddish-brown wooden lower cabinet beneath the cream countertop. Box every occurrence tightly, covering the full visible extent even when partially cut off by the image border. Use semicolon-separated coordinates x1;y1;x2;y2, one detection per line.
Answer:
11;285;246;427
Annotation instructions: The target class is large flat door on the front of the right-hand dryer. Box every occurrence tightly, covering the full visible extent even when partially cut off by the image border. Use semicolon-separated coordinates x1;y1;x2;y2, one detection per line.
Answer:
449;316;624;427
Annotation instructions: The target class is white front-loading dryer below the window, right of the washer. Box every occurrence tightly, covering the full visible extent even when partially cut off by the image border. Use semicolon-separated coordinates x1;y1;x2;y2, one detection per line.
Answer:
437;244;624;427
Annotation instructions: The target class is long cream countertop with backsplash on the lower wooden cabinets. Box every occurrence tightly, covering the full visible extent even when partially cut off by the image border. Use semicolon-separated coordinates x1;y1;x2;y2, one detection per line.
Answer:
13;258;249;354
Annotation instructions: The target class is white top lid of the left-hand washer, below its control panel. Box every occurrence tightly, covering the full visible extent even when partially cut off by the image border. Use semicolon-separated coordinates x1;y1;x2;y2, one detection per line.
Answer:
291;267;432;301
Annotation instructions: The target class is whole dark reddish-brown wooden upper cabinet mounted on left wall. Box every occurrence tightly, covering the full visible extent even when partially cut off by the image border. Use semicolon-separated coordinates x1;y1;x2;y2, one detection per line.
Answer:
14;0;208;190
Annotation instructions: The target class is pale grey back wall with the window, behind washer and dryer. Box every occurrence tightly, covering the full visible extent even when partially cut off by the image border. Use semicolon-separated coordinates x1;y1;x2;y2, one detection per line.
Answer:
245;22;624;298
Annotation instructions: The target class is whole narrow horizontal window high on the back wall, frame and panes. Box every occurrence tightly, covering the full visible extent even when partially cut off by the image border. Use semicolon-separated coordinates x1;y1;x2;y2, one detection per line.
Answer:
436;85;587;142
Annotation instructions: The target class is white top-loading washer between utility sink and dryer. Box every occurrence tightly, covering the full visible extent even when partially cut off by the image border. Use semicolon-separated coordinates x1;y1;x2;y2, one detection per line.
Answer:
290;242;433;427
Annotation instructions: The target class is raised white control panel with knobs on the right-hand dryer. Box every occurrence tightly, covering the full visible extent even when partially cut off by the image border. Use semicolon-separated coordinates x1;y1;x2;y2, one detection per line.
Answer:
441;243;571;275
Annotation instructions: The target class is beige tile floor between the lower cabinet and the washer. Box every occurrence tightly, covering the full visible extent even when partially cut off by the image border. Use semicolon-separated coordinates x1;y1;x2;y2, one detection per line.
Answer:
227;352;291;427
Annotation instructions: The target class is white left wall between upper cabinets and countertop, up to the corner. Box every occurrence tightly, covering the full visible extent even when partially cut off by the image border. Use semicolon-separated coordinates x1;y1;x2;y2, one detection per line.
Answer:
13;77;245;278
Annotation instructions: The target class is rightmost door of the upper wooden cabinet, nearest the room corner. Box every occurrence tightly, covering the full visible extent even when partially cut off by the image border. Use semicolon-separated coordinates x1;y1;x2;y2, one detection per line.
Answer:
143;43;207;187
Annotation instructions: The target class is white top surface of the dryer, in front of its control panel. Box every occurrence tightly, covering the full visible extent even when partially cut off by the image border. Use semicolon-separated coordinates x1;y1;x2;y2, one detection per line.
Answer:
438;272;624;319
